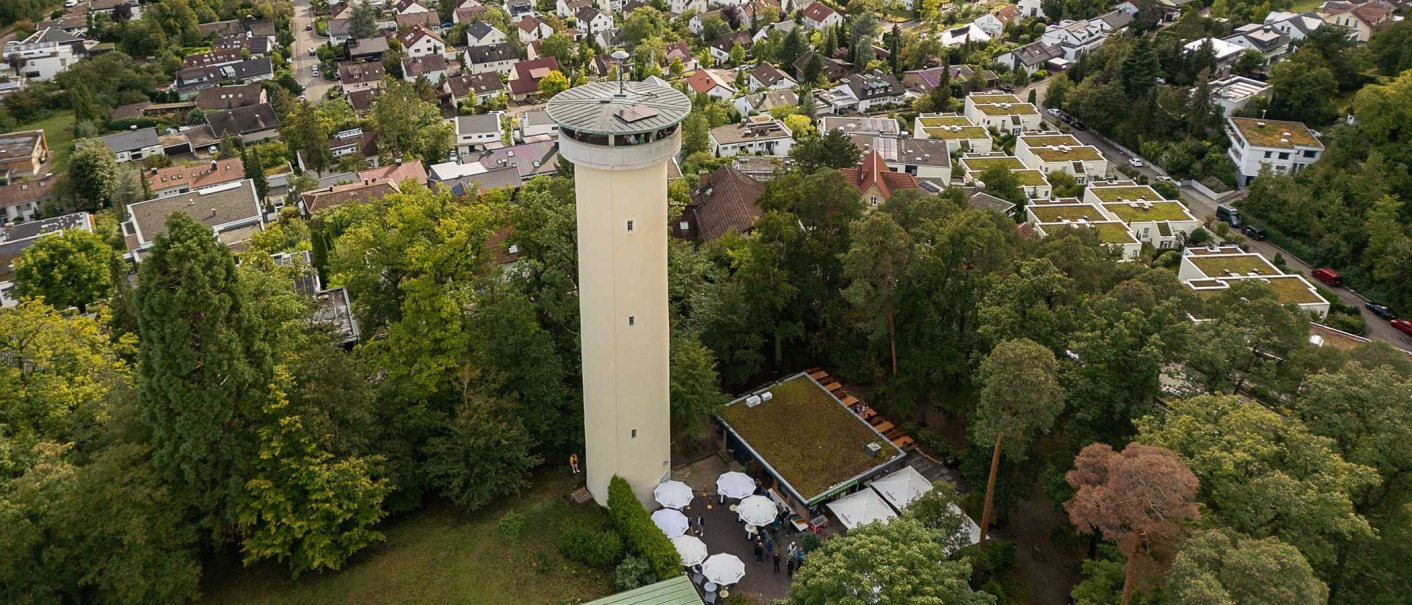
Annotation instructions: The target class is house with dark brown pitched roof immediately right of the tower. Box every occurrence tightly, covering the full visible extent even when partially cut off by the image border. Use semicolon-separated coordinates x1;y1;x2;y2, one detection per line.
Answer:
672;165;765;243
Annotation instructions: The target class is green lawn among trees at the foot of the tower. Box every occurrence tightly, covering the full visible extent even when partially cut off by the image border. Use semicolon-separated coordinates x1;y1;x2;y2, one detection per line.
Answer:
202;468;613;605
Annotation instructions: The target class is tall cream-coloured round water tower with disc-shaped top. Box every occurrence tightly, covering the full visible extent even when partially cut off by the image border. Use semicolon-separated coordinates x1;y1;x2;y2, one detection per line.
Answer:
546;73;692;505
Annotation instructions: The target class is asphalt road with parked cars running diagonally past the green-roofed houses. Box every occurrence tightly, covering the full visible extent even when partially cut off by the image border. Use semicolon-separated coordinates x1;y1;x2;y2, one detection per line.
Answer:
1019;84;1412;349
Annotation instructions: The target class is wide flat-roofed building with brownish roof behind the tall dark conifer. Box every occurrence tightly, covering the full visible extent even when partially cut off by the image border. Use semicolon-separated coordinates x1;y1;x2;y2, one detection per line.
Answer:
123;178;264;263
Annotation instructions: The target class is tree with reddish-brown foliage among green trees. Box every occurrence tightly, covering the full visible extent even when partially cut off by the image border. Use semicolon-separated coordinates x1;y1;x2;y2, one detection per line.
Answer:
1063;442;1200;605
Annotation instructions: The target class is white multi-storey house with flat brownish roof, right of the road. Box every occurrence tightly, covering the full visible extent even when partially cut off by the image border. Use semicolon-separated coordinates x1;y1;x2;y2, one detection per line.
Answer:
1226;117;1323;187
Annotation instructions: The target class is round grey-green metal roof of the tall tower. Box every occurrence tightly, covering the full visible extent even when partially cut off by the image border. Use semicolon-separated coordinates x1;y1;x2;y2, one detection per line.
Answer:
545;82;692;134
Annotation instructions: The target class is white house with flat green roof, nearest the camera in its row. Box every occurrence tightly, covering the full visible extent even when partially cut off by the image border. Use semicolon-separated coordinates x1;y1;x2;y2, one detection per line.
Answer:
1176;246;1329;319
